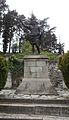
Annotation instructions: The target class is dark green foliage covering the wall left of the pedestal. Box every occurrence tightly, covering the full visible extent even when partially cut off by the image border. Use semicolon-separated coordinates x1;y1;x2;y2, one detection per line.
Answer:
9;55;24;85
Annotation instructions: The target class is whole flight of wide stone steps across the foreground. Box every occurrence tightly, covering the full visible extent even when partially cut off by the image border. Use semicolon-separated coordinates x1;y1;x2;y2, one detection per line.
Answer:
0;98;69;120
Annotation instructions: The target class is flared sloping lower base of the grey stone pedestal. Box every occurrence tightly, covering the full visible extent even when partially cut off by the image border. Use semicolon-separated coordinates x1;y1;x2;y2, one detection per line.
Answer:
16;78;57;95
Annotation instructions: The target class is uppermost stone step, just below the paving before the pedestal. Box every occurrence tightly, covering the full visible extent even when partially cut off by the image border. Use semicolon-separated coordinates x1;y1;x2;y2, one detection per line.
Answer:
0;98;69;105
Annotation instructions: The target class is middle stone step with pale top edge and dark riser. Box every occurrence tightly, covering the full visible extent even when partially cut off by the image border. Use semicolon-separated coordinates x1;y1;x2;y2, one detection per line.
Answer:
0;103;69;117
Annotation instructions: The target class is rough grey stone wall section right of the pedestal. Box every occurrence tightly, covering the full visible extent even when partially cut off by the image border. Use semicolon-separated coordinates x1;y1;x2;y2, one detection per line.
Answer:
49;62;63;89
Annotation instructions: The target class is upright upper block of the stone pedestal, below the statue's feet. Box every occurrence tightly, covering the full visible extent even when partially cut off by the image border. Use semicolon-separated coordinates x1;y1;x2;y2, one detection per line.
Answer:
24;55;49;78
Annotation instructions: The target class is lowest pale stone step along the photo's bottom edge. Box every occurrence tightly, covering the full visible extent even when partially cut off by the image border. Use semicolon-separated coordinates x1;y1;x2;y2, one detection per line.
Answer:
0;113;69;120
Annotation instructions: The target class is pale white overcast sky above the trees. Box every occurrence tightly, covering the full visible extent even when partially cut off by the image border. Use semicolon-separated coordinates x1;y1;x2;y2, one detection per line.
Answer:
6;0;69;51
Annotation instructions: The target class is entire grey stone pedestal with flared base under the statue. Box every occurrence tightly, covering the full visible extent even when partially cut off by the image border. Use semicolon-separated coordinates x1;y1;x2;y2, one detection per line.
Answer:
17;55;54;95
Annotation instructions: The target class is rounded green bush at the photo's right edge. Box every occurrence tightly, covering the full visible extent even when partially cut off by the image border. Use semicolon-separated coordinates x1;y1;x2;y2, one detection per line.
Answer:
58;52;69;88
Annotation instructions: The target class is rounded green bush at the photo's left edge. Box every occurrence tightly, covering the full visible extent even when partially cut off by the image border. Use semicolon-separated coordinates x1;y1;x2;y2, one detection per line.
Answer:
0;55;8;90
